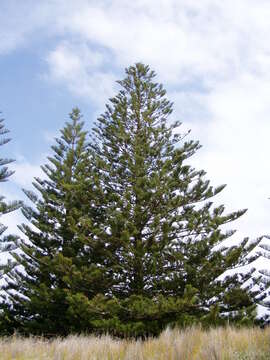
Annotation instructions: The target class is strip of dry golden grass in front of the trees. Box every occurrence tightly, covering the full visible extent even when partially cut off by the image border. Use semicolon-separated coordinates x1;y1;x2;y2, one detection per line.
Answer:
0;327;270;360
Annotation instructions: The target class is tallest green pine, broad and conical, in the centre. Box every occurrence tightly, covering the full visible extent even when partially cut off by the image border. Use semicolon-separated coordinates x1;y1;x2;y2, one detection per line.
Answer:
79;64;259;336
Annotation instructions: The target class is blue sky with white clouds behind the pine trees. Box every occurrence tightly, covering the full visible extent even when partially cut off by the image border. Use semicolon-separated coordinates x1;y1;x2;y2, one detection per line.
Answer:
0;0;270;270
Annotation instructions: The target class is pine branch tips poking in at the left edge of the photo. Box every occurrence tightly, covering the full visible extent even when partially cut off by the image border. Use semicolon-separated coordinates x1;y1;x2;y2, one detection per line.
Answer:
0;114;20;266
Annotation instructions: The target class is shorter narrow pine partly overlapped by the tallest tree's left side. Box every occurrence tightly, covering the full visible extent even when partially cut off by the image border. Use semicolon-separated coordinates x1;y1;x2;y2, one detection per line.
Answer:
0;109;106;336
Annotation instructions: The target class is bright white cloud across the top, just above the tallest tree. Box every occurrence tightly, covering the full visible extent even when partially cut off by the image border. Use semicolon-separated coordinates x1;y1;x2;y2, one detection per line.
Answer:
42;0;270;84
